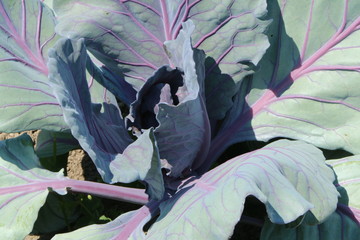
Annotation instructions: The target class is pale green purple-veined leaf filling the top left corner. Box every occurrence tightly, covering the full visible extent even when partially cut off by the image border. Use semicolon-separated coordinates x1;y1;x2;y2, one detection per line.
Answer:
0;0;68;132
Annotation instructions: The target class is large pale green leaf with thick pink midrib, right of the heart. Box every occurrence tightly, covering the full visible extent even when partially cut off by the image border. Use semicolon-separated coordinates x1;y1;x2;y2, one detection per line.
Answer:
210;0;360;161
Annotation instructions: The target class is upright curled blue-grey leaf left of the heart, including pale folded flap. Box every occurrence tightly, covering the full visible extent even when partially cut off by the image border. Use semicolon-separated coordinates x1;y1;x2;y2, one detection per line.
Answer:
49;39;164;199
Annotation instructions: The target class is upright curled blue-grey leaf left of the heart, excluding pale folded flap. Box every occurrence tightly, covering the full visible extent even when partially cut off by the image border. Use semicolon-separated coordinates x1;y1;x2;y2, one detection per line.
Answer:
49;39;131;181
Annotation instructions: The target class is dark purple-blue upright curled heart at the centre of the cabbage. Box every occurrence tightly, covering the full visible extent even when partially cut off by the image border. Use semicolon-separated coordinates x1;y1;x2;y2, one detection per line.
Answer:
131;20;210;177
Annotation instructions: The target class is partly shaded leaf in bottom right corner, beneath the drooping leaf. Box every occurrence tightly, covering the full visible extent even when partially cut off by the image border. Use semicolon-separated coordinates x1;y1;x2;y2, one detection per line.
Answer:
261;155;360;240
